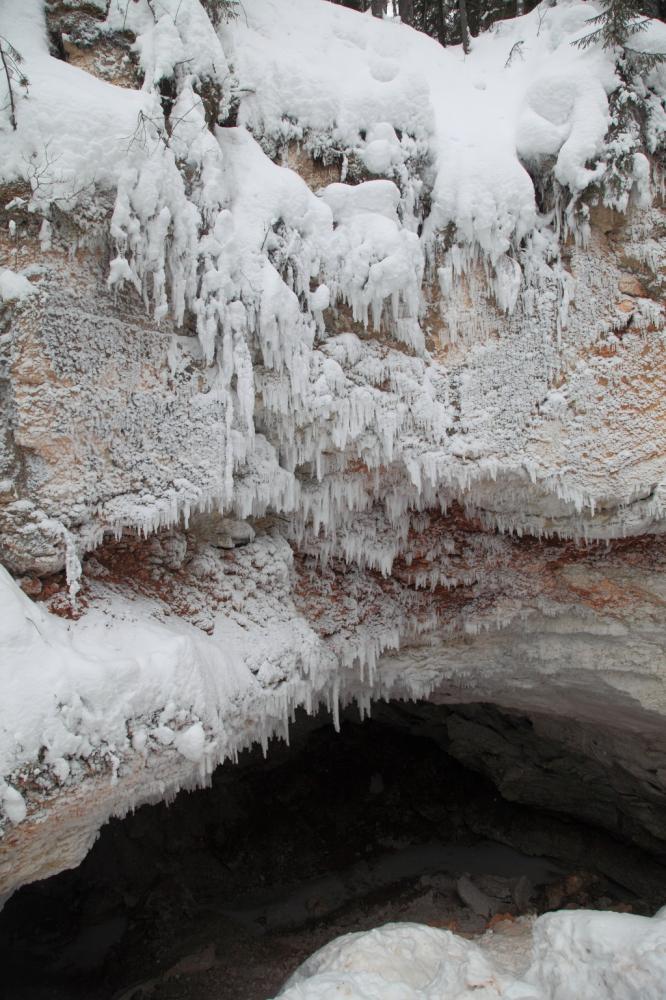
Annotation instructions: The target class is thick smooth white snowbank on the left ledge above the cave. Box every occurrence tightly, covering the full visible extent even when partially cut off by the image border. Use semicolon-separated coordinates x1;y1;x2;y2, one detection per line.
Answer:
0;567;282;808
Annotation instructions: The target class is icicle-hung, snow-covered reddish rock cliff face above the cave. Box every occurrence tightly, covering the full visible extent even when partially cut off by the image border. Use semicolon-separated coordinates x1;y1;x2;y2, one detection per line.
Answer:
0;0;666;895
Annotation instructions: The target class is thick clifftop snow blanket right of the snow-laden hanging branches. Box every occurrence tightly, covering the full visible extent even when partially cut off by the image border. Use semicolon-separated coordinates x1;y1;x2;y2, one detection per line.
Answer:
230;2;614;264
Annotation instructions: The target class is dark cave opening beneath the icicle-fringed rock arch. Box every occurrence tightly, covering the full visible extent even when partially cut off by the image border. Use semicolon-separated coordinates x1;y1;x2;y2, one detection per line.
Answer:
0;702;666;1000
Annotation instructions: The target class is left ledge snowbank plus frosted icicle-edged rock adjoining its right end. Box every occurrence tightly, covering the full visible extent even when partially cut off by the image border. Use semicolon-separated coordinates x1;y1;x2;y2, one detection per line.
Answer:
0;524;336;826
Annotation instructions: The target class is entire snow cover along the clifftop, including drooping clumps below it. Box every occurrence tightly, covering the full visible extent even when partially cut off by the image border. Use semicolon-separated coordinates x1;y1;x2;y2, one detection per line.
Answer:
0;0;648;340
